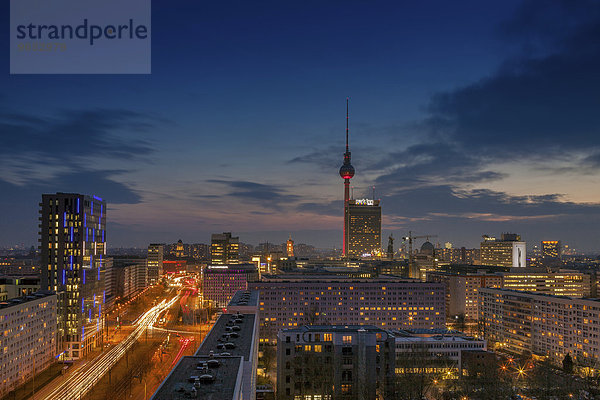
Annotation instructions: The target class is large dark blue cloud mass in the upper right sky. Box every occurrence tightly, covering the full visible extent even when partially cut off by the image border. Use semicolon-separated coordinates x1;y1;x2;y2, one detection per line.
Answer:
423;2;600;160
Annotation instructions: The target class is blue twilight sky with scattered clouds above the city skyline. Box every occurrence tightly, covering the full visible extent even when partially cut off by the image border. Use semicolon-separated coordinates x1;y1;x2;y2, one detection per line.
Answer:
0;0;600;250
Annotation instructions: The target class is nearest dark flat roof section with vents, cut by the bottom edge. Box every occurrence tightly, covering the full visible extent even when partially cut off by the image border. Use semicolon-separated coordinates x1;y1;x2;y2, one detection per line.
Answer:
152;356;242;400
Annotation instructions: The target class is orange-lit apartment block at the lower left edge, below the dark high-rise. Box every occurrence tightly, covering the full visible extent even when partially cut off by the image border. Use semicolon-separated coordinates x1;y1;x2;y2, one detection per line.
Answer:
0;293;57;397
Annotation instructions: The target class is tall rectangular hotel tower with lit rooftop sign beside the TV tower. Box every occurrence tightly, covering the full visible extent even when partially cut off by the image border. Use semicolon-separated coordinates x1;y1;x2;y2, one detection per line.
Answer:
346;199;381;258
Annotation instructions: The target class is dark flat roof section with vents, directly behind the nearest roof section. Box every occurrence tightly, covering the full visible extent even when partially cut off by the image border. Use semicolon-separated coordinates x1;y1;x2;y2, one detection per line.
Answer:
196;314;256;361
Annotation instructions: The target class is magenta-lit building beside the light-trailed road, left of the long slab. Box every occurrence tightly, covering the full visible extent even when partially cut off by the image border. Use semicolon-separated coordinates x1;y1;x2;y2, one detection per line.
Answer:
202;264;258;307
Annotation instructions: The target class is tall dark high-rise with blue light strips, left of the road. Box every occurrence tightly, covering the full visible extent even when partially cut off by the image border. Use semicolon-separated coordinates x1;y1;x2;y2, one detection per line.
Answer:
39;193;106;359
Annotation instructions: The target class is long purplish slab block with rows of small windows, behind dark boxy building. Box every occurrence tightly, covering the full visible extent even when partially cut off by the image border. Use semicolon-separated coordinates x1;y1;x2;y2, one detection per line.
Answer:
249;275;445;343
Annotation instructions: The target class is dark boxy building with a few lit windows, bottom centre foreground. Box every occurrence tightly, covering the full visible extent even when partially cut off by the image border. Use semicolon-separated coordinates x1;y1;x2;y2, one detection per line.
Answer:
277;325;395;400
